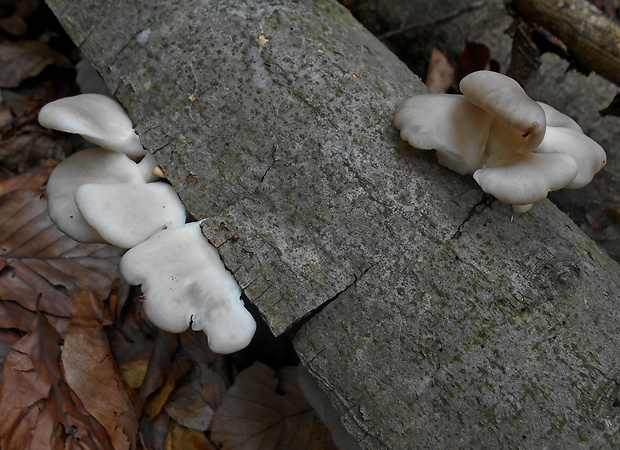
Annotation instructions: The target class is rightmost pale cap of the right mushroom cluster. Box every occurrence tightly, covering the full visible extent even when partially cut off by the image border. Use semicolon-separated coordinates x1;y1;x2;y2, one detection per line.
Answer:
535;127;607;189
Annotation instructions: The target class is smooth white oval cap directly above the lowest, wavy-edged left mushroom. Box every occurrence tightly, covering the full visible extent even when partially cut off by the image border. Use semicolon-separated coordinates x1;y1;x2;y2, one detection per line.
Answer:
75;182;185;248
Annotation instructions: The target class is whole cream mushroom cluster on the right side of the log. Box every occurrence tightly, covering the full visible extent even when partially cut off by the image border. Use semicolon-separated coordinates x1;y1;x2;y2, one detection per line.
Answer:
394;71;606;212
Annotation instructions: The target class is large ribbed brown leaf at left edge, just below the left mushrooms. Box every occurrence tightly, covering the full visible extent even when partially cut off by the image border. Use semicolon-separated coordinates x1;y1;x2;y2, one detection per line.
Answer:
0;188;127;317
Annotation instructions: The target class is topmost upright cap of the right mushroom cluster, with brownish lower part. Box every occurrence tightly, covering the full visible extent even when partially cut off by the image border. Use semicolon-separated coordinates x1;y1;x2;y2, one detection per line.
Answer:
459;70;546;154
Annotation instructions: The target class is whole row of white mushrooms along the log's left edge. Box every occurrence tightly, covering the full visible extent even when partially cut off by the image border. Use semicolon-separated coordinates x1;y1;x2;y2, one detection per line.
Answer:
39;94;256;353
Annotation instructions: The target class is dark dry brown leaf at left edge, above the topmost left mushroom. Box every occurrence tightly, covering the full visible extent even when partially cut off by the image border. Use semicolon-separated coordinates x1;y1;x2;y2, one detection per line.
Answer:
0;41;71;88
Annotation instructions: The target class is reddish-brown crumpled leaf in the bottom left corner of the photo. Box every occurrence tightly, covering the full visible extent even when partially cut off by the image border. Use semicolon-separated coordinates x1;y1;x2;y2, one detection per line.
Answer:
0;315;112;450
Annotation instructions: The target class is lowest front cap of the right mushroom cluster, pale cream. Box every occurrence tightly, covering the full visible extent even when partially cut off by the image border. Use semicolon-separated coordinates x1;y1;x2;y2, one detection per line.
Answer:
474;153;577;209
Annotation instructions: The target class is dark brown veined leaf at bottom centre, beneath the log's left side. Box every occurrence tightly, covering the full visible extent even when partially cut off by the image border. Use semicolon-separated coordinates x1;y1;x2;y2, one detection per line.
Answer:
211;362;336;450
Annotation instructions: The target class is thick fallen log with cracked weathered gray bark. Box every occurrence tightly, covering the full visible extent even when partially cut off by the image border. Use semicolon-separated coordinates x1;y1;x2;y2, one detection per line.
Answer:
48;0;620;449
